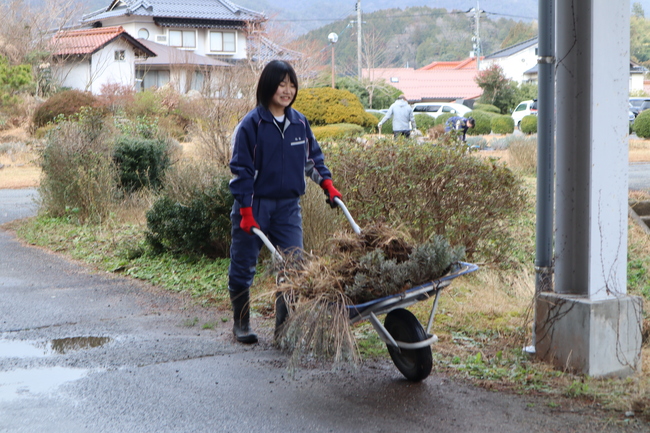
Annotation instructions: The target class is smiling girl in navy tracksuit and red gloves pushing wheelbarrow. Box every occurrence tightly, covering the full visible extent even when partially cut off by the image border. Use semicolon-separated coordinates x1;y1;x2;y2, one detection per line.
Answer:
228;60;341;344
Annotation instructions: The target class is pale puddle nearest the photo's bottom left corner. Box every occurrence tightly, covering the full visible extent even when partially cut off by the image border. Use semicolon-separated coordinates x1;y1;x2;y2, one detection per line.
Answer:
0;367;88;401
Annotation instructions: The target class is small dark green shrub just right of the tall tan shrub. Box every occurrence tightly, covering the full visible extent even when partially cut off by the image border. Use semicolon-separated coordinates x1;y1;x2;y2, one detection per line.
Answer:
113;135;171;192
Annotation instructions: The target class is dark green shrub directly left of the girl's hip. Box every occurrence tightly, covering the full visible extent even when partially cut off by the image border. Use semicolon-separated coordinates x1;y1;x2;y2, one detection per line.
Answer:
146;173;234;257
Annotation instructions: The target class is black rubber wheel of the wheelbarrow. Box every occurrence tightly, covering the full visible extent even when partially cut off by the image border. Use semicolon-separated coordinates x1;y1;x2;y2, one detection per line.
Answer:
384;308;433;382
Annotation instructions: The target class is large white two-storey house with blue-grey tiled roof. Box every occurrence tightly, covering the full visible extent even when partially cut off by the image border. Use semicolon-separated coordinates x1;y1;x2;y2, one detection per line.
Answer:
73;0;300;92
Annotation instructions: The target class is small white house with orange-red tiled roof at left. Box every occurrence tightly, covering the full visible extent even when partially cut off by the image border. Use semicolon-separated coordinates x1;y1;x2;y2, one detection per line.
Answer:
51;26;156;94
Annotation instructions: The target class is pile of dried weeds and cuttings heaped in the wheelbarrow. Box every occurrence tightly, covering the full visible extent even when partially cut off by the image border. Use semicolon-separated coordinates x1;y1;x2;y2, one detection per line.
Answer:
277;225;464;368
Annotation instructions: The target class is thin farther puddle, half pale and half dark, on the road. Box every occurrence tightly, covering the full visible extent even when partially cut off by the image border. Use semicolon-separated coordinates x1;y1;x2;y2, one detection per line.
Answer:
0;337;113;358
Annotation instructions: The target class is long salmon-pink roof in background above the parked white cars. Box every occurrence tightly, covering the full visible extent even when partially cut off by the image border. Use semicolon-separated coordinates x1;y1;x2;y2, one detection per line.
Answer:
363;68;483;102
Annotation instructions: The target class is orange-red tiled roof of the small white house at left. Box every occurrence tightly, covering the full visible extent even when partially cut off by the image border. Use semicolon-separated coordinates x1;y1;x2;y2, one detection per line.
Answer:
52;26;128;56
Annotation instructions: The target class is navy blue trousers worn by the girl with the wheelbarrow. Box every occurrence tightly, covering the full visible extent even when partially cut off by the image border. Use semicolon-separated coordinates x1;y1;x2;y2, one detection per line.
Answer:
228;198;303;295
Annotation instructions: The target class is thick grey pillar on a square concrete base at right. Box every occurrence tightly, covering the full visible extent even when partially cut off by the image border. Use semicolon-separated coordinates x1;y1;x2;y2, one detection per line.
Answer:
535;0;641;376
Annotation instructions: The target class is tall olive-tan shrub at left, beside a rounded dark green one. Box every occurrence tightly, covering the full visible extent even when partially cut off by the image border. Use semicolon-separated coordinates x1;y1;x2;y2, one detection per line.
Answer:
39;122;116;222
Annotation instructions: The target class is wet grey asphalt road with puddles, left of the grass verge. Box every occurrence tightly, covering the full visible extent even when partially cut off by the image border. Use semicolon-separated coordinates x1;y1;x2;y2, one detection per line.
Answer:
0;190;647;433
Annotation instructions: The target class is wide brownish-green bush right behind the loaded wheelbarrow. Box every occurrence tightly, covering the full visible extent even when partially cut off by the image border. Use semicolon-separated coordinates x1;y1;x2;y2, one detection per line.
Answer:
327;140;525;263
